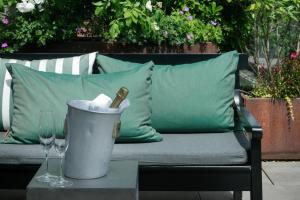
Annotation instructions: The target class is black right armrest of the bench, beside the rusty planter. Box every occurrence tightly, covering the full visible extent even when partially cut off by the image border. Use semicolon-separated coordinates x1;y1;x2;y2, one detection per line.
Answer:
234;90;263;139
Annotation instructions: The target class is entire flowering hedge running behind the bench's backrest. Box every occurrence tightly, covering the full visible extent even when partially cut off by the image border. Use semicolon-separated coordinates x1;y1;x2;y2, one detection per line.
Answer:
0;0;250;52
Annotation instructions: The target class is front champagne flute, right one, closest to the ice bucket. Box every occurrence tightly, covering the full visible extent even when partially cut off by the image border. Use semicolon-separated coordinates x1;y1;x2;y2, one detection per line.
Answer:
50;132;73;187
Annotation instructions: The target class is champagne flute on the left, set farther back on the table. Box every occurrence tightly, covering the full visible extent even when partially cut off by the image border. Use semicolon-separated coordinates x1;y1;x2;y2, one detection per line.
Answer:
36;110;55;182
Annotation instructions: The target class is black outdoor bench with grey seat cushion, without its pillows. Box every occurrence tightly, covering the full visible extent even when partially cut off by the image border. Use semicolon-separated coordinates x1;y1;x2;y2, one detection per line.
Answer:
0;53;262;200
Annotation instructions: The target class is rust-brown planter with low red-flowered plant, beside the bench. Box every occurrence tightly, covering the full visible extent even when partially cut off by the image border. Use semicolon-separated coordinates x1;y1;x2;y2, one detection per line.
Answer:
245;53;300;159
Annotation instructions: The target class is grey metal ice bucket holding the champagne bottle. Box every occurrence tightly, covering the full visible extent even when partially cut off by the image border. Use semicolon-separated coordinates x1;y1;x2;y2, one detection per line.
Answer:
64;100;121;179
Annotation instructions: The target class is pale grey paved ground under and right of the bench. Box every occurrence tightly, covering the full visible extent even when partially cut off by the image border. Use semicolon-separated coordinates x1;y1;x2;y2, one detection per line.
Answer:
0;162;300;200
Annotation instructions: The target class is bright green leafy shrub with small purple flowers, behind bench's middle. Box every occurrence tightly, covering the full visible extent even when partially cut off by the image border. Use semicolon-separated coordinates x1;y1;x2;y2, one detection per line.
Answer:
94;0;223;45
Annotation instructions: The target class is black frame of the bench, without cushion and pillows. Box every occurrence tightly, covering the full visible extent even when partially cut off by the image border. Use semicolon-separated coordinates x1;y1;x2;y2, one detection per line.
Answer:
0;53;262;200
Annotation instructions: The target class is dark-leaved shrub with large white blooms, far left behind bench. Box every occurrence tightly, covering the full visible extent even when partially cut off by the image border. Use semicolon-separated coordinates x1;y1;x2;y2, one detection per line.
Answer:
0;0;92;52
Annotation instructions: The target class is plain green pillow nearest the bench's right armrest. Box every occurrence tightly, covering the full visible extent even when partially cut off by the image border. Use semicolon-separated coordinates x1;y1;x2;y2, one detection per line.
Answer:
96;51;239;132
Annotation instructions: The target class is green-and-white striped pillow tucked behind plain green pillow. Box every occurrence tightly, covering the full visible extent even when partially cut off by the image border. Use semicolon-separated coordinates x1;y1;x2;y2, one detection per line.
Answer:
0;52;96;131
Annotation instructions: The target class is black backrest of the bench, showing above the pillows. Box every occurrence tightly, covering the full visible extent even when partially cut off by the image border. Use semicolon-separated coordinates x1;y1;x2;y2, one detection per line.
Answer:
0;53;248;89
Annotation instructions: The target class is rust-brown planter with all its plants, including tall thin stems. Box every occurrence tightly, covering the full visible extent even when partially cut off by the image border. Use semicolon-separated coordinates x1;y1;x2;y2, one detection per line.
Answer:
246;0;300;159
